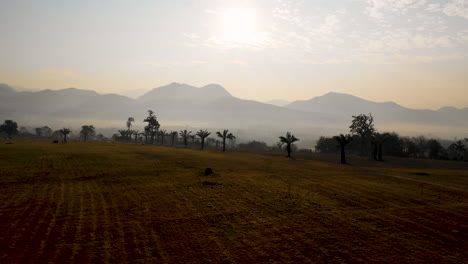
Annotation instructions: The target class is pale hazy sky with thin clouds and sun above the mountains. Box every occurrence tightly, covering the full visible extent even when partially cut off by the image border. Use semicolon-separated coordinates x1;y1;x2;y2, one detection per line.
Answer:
0;0;468;109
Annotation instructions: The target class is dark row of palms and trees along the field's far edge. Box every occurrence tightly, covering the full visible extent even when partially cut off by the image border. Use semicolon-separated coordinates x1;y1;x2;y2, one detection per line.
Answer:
0;110;468;163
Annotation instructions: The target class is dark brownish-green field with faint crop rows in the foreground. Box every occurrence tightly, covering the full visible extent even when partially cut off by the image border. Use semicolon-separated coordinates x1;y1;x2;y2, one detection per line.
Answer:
0;141;468;263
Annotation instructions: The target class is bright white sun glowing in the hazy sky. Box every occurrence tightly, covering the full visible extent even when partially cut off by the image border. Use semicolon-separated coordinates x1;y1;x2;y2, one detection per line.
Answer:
219;7;262;45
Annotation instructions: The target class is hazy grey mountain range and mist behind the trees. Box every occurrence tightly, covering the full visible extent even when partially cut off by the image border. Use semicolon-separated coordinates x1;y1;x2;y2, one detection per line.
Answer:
0;83;468;140
